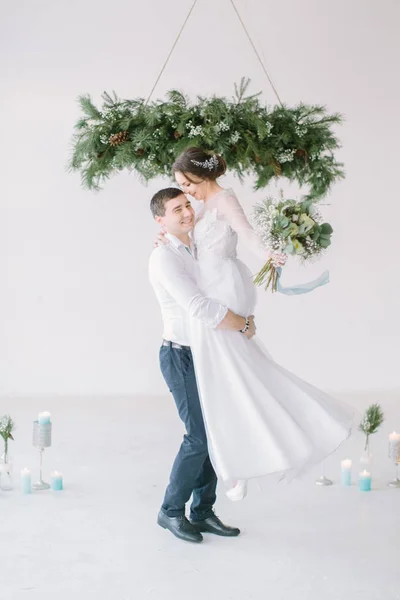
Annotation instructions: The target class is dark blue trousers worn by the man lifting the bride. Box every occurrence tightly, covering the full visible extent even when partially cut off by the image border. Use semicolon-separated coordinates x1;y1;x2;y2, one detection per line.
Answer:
160;346;217;521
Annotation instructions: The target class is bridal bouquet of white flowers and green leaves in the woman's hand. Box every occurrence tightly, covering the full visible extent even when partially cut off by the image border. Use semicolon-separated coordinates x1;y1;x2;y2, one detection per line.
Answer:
253;197;333;292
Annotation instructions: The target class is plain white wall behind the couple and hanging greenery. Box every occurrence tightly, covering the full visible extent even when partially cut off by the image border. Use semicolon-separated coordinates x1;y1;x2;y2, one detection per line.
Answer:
0;0;400;395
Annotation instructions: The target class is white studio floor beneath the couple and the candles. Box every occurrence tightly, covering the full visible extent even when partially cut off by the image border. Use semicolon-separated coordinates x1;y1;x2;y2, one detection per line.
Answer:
0;394;400;600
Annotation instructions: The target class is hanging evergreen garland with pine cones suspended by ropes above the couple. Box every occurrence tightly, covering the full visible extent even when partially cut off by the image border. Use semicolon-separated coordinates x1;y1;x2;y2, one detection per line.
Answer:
70;79;344;202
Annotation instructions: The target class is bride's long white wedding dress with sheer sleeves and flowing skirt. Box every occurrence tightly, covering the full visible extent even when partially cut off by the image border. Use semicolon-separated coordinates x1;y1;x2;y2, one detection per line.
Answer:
190;190;353;500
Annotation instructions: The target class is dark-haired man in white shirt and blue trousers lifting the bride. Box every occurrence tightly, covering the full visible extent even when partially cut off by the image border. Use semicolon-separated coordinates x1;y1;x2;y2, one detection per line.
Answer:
149;188;255;542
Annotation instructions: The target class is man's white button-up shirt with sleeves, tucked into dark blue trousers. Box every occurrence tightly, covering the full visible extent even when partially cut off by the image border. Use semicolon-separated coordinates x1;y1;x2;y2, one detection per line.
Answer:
149;234;228;346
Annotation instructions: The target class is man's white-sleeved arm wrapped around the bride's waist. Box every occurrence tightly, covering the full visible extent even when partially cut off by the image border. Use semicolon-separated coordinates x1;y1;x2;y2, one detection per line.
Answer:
150;249;250;331
